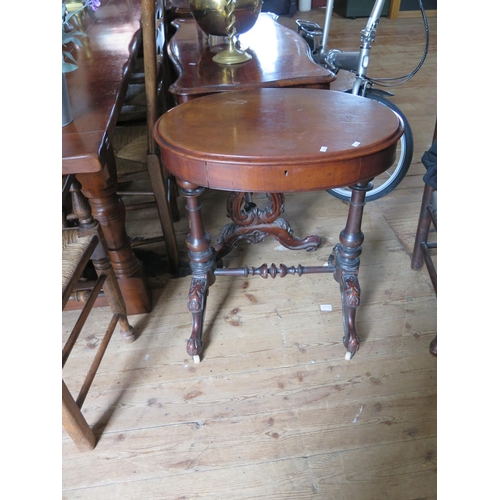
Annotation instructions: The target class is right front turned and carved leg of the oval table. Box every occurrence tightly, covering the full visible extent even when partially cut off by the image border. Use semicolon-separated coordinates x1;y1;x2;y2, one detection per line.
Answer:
330;183;371;360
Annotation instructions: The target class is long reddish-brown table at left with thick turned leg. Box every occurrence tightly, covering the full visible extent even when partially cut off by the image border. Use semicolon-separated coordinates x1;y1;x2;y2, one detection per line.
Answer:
62;0;151;314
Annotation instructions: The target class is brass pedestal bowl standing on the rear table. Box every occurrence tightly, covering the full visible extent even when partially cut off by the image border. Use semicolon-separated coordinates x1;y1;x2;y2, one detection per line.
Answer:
189;0;262;64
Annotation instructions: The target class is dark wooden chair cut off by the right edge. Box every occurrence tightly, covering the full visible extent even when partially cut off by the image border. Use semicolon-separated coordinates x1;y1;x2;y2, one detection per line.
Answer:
411;141;437;356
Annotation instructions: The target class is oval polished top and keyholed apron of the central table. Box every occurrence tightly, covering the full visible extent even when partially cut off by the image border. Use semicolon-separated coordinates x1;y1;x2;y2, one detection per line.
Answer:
154;88;403;192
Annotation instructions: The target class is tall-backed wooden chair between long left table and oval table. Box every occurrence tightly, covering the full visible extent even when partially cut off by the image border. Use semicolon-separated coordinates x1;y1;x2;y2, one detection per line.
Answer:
111;0;179;273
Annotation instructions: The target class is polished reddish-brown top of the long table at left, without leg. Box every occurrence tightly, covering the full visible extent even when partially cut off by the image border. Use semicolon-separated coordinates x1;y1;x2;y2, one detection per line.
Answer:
62;0;141;174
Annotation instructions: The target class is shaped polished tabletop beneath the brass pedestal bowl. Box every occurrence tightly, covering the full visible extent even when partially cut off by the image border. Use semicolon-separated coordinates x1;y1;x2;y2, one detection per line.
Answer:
168;13;335;103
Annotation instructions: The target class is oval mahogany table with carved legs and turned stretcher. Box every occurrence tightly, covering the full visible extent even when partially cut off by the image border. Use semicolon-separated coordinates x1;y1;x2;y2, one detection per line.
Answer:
154;88;404;362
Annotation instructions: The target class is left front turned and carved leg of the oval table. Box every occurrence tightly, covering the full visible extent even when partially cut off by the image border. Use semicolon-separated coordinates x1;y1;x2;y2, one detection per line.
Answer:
177;180;215;363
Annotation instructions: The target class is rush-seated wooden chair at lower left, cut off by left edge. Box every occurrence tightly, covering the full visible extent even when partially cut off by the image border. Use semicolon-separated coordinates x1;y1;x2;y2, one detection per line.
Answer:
62;179;135;451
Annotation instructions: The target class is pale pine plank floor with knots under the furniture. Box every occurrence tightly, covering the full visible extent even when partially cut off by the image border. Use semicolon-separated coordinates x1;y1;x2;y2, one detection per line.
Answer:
62;9;437;500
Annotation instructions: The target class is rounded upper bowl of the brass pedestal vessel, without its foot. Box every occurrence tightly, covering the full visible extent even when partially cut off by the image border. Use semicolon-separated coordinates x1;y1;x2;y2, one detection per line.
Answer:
189;0;262;36
